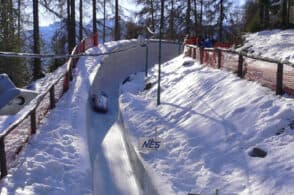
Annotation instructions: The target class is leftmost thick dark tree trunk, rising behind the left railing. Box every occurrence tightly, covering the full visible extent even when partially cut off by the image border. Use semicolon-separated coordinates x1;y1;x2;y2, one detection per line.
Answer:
33;0;43;80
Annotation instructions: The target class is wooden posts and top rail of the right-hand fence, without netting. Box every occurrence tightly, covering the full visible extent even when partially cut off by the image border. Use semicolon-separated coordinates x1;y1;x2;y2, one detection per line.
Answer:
185;45;294;95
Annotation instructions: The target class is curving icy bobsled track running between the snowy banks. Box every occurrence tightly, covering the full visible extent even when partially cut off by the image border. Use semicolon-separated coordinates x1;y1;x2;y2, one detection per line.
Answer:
86;41;179;195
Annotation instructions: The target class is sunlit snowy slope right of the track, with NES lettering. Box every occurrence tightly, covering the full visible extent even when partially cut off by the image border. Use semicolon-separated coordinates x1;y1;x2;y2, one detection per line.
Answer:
120;56;294;194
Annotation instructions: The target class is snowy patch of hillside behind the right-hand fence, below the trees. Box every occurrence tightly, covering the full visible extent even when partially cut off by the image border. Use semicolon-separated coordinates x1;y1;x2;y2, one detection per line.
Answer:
238;29;294;63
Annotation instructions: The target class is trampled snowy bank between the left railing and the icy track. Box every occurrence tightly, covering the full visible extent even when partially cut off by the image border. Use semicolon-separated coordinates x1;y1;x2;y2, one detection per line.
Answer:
0;42;125;195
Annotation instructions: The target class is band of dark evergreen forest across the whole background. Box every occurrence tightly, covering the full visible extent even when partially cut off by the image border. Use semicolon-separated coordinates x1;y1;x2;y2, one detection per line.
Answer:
0;0;294;86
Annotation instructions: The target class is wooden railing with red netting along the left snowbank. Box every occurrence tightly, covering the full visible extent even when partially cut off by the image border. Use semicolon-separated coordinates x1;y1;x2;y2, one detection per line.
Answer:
0;34;98;178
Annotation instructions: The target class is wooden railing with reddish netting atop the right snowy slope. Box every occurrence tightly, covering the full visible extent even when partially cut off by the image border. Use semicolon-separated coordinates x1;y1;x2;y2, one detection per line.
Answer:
185;45;294;95
